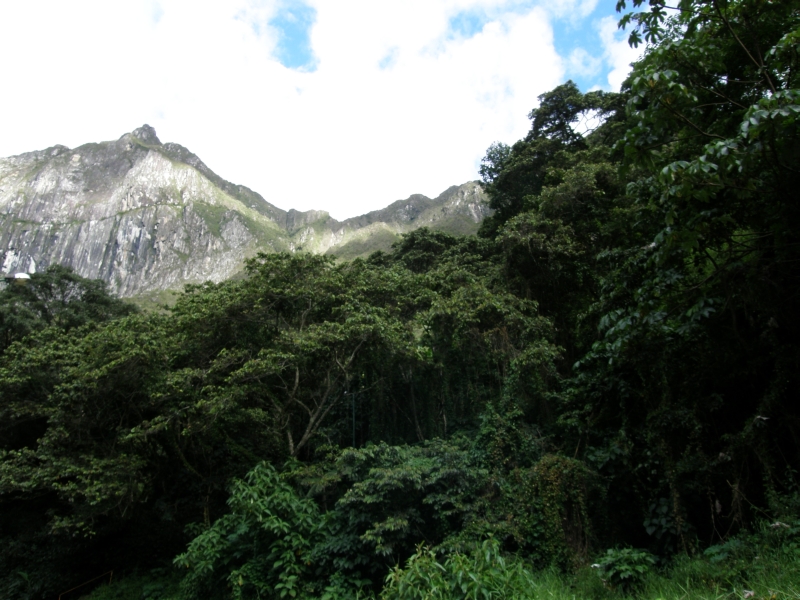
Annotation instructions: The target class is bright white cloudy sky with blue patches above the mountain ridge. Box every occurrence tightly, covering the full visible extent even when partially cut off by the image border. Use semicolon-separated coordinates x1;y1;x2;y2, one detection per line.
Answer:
0;0;641;219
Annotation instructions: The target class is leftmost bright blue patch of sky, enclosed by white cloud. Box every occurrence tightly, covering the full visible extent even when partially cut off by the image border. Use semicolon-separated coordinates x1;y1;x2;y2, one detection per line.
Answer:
269;2;317;72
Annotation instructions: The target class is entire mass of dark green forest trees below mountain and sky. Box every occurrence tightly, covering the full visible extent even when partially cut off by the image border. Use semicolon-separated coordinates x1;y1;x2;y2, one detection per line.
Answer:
0;0;800;598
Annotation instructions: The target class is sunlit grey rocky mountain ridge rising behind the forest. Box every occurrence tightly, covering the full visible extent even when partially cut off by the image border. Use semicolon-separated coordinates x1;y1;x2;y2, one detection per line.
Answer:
0;125;488;297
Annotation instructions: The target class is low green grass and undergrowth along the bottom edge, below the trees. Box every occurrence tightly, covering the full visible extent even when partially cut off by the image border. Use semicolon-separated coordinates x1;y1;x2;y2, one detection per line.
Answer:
90;523;800;600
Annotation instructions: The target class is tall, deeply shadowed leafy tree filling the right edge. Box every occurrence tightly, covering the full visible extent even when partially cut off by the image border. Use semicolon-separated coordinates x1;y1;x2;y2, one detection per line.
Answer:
564;0;800;549
